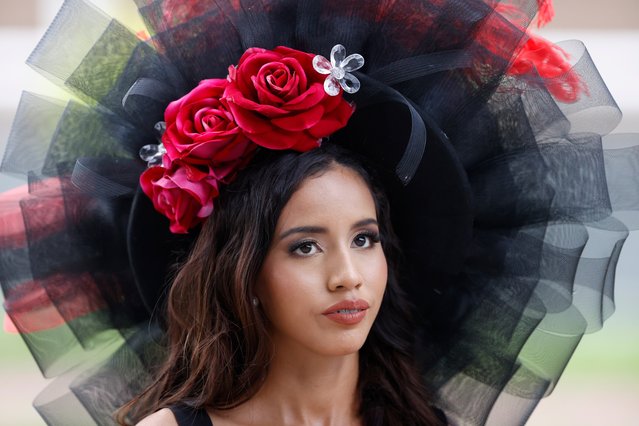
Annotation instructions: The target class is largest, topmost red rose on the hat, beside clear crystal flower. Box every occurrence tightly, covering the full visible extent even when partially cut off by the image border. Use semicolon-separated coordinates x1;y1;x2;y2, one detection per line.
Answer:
224;46;354;151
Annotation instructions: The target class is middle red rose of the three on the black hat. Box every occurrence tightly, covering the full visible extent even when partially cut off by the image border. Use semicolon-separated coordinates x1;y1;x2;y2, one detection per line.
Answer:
162;79;255;165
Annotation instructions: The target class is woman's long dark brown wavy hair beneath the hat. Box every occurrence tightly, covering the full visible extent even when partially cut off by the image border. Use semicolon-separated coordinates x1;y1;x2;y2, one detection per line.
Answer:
117;143;441;425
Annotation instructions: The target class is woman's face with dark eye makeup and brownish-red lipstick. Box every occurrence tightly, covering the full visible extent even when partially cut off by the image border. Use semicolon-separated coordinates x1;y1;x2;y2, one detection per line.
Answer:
256;166;387;356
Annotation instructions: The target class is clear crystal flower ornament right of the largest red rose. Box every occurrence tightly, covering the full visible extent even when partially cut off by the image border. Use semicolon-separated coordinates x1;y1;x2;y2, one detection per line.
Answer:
313;44;364;96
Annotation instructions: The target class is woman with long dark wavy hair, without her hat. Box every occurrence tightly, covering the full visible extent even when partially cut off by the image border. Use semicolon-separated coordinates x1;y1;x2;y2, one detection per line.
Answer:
129;143;440;425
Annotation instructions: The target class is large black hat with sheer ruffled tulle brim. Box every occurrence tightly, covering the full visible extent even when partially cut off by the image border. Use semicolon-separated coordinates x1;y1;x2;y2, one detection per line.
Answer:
0;0;639;425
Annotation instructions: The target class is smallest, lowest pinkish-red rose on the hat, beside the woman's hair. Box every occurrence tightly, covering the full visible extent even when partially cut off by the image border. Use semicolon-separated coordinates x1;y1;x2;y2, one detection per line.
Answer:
140;160;219;234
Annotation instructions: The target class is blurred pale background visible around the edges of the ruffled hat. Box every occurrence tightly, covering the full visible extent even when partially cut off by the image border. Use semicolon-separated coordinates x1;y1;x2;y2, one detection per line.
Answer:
0;0;639;426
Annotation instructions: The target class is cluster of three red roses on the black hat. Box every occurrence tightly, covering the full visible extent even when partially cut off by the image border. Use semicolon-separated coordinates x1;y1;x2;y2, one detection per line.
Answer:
140;47;354;233
